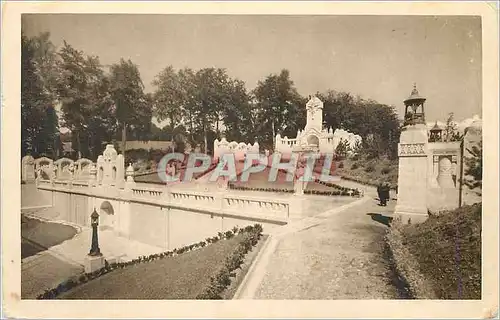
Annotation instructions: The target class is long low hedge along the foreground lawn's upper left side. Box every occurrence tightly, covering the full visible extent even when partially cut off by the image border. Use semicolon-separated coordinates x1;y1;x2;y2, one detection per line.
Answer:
36;224;262;300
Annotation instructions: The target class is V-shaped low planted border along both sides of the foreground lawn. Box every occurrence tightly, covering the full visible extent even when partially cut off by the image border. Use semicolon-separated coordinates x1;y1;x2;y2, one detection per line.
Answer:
37;224;262;299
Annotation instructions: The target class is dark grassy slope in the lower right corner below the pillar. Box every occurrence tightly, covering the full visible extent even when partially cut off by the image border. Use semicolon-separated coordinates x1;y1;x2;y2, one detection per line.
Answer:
401;203;481;299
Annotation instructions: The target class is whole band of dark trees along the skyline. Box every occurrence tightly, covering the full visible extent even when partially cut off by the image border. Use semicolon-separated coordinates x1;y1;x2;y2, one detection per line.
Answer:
21;34;406;158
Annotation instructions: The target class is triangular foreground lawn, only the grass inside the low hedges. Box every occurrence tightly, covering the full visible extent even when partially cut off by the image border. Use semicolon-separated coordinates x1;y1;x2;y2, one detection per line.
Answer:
58;234;244;300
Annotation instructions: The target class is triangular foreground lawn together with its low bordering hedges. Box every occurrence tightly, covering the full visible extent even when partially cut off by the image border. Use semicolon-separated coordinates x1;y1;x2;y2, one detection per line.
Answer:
38;225;262;299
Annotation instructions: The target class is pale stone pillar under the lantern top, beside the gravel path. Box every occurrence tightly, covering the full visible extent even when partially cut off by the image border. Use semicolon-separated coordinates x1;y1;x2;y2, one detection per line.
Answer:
394;124;428;224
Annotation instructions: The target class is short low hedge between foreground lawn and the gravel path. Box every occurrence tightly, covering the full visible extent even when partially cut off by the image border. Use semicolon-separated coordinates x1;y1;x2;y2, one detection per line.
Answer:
196;224;262;300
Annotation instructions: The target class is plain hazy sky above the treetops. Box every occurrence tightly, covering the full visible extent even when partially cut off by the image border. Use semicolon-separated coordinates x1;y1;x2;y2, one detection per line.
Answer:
22;14;482;122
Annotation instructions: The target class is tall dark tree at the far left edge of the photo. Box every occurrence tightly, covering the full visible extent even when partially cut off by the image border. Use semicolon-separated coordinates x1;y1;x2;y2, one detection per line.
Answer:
21;33;58;157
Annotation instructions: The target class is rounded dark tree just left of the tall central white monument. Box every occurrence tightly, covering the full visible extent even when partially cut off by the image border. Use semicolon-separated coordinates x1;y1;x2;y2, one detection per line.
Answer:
253;69;306;146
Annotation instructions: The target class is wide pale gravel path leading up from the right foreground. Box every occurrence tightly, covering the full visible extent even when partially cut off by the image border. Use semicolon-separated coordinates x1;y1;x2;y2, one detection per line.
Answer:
236;188;396;299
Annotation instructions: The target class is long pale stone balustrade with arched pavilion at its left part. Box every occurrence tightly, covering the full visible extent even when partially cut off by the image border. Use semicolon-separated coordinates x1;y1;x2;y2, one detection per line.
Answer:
31;144;290;223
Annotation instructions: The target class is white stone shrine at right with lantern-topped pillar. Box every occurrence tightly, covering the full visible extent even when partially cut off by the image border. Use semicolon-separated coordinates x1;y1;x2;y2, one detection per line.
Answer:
395;86;481;223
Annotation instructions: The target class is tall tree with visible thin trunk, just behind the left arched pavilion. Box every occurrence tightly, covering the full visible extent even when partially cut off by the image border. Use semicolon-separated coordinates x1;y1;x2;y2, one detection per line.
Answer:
109;59;152;152
